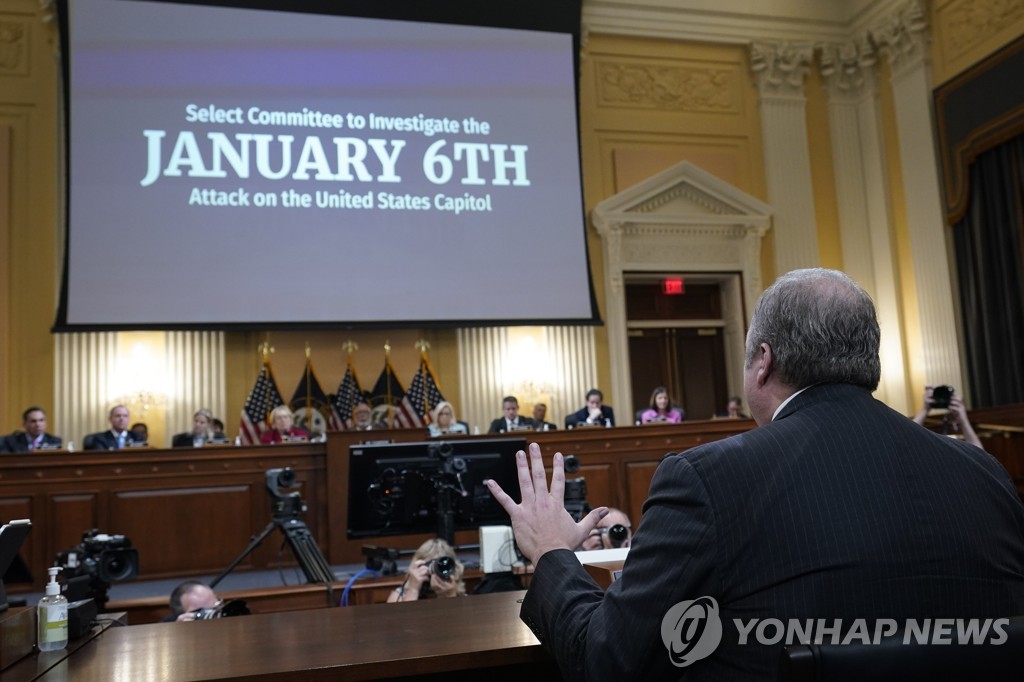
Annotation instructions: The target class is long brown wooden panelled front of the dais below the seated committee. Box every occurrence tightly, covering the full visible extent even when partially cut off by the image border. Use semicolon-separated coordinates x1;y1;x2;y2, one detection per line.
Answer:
0;420;753;590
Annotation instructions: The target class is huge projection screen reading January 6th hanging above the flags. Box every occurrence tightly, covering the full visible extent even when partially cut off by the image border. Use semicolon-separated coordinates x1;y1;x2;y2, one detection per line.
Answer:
55;0;597;330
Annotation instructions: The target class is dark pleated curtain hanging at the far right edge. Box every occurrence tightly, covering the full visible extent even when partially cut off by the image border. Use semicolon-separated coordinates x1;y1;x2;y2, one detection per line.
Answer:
950;135;1024;408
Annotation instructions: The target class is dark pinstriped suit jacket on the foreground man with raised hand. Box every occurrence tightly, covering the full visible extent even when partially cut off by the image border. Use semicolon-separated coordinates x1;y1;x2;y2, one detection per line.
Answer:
521;384;1024;680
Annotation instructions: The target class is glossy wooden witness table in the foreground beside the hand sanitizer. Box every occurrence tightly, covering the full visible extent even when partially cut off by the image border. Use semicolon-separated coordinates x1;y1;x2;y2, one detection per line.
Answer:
45;592;558;682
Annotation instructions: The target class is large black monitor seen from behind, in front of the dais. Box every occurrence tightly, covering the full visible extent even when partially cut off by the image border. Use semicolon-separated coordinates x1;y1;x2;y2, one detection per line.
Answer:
348;438;526;542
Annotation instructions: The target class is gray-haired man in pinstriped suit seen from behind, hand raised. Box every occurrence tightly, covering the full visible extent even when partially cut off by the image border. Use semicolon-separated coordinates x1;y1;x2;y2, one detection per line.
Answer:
489;269;1024;680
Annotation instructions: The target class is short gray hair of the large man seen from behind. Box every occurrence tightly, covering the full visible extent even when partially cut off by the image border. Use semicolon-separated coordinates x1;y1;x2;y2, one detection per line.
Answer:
745;267;882;391
